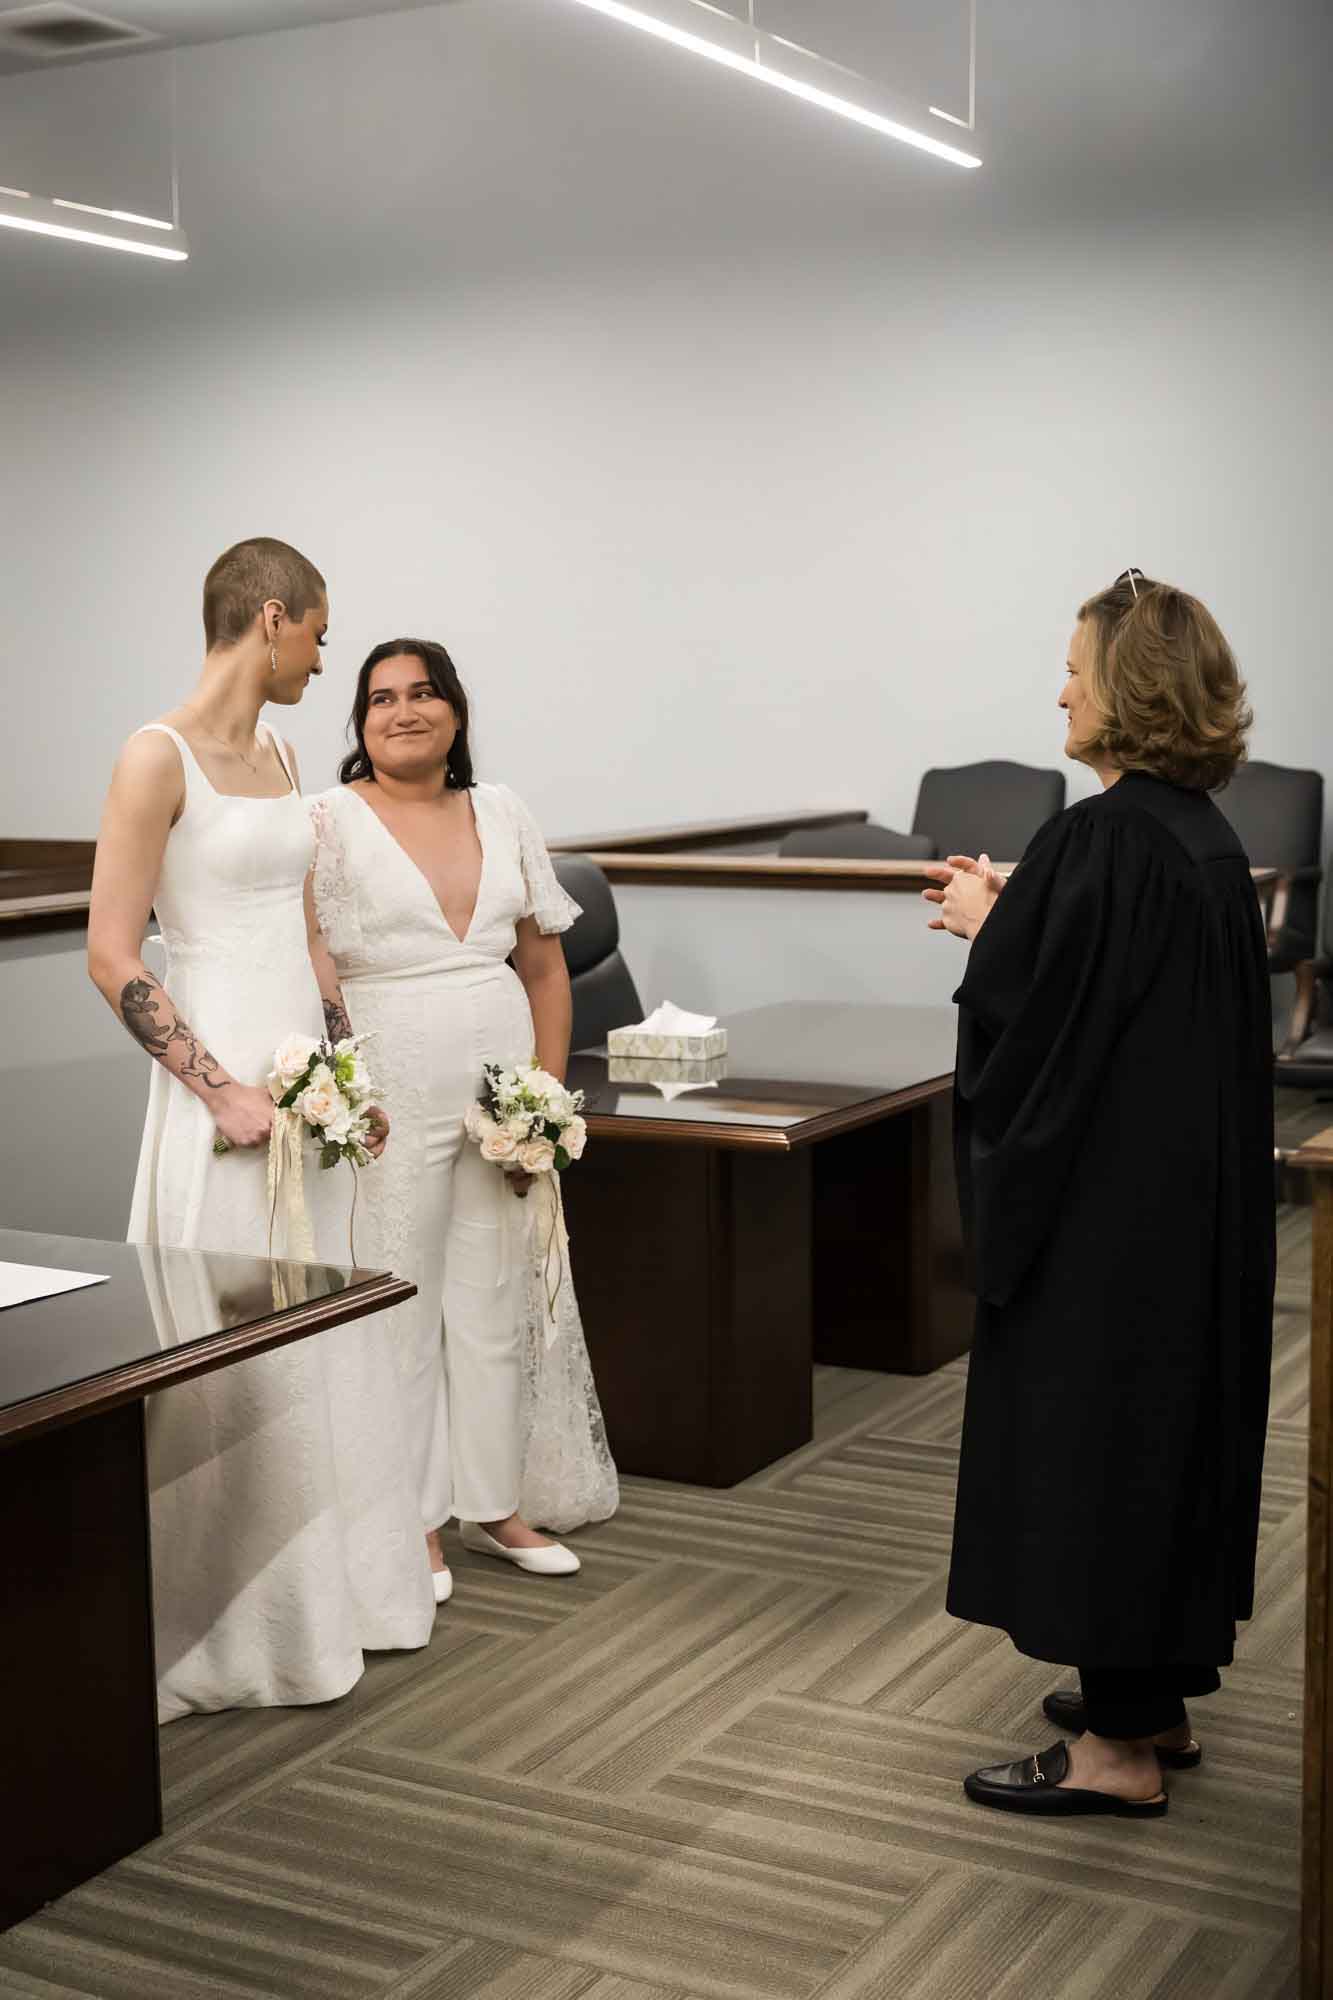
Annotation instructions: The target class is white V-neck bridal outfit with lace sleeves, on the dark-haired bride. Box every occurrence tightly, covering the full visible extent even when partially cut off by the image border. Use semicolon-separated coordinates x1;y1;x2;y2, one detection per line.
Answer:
310;784;618;1534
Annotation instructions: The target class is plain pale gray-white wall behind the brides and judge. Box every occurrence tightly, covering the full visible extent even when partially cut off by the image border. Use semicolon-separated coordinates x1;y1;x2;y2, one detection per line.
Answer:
0;0;1333;836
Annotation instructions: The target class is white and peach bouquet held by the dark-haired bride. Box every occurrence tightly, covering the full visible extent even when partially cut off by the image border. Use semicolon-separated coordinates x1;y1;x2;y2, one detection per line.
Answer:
462;1062;588;1346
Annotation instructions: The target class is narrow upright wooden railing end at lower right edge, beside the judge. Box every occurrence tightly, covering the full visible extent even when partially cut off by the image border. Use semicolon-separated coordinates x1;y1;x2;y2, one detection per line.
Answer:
1287;1128;1333;2000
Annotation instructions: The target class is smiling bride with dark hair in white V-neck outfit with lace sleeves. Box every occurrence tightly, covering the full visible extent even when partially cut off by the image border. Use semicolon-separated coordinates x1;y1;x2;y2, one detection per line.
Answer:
310;638;618;1602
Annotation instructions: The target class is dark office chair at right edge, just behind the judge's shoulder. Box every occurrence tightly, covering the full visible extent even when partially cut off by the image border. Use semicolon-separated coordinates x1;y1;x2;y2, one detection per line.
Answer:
1217;762;1323;972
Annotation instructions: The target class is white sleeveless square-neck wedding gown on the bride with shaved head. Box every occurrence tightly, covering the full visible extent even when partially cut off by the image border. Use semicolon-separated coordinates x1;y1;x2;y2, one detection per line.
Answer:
130;724;434;1720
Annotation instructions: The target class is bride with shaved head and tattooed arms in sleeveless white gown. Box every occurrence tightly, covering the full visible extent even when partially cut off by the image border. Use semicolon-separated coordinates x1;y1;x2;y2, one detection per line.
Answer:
88;538;434;1720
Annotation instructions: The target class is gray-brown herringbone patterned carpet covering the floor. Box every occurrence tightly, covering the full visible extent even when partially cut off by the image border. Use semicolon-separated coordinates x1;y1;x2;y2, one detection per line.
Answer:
0;1210;1309;2000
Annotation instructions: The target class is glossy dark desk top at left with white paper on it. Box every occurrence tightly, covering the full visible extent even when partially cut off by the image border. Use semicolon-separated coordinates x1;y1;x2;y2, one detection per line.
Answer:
0;1230;416;1444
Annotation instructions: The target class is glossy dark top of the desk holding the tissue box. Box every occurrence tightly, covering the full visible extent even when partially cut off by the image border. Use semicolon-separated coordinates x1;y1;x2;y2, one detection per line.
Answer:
568;1002;959;1172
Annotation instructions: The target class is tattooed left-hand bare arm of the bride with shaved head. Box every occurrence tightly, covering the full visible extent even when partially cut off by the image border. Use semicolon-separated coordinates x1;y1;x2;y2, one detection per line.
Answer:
88;732;272;1146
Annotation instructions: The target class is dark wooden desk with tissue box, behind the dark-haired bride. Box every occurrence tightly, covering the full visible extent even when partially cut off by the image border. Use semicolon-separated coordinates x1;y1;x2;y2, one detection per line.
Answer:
564;1004;973;1486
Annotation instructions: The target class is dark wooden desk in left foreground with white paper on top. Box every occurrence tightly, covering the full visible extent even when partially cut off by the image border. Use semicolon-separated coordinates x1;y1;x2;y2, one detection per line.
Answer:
0;1230;416;1928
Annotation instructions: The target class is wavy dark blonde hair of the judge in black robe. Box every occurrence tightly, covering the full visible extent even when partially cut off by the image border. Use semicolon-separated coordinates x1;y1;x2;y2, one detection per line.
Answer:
1079;570;1255;792
